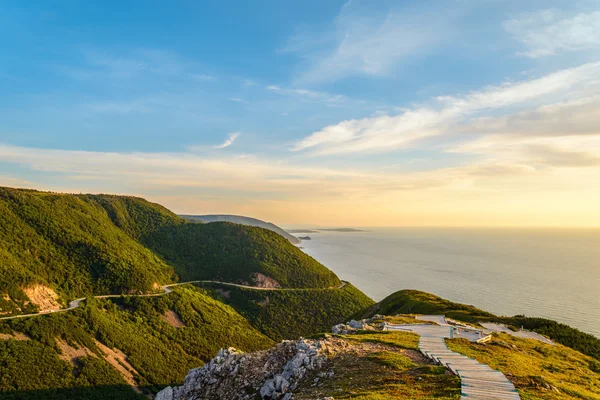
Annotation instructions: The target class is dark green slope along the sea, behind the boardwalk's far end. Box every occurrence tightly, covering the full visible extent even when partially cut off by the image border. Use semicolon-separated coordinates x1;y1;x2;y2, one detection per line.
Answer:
355;290;600;360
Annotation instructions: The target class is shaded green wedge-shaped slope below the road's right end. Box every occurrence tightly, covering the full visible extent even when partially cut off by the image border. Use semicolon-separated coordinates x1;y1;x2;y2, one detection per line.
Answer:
199;284;373;340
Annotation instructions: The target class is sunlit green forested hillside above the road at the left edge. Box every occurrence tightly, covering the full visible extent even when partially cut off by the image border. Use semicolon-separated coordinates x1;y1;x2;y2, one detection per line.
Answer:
0;188;175;312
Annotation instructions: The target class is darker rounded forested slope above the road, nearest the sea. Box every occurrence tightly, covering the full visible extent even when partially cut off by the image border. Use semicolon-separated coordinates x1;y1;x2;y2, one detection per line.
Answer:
144;222;341;287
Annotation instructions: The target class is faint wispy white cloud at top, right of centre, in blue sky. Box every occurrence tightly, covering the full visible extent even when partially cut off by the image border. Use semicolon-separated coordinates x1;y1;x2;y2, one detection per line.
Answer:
284;2;454;83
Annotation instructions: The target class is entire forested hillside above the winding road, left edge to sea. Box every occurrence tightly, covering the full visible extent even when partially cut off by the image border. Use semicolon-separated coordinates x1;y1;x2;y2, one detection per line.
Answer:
0;188;340;315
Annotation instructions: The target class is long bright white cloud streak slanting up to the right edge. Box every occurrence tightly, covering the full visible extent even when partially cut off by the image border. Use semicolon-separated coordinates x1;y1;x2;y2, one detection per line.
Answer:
293;63;600;155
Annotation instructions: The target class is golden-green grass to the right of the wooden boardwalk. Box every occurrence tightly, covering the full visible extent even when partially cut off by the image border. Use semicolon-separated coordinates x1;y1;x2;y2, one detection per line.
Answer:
447;334;600;400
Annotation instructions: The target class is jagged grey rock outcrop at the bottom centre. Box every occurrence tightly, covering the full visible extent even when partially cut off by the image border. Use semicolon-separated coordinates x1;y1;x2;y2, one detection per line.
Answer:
156;339;345;400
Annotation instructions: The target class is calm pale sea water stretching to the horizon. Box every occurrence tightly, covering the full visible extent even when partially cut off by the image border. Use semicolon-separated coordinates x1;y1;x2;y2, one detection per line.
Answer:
299;228;600;337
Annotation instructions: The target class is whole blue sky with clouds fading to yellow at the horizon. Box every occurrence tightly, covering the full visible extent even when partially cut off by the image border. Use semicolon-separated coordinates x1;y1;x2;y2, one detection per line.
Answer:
0;0;600;227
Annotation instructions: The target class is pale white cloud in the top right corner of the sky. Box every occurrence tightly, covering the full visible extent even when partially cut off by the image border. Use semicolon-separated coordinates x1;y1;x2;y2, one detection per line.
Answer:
504;10;600;58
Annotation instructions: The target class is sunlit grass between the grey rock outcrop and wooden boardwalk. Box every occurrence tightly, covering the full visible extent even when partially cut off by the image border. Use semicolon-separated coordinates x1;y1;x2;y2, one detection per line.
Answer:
294;333;460;400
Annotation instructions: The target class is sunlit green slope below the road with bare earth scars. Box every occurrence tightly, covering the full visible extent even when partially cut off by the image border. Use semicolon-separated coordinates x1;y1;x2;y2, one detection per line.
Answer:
0;288;273;399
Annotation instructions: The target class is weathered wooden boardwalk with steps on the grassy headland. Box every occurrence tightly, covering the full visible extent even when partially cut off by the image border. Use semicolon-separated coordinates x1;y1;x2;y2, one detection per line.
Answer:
386;315;521;400
